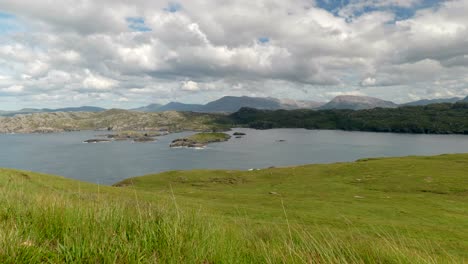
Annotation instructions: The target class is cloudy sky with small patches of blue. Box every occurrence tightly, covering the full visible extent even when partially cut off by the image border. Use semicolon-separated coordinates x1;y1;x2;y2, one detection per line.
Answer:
0;0;468;110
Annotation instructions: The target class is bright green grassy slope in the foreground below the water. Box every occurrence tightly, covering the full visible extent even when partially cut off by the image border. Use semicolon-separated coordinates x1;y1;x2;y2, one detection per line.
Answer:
0;154;468;263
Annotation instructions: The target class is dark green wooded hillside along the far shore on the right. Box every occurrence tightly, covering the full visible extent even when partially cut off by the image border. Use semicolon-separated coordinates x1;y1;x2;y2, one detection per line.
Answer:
216;102;468;134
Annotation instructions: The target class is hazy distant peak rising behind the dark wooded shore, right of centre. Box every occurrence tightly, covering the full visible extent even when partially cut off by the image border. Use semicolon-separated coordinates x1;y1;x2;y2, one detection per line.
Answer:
319;95;398;110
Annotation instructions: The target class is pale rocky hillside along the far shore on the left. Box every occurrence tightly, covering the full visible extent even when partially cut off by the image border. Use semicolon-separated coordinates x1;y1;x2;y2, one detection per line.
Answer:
0;109;222;133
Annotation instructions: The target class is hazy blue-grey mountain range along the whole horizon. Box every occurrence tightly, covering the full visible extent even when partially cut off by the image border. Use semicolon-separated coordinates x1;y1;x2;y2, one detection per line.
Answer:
0;95;468;116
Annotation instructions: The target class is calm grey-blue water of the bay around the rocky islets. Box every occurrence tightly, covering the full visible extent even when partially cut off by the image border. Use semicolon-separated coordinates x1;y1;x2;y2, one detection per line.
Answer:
0;129;468;184
